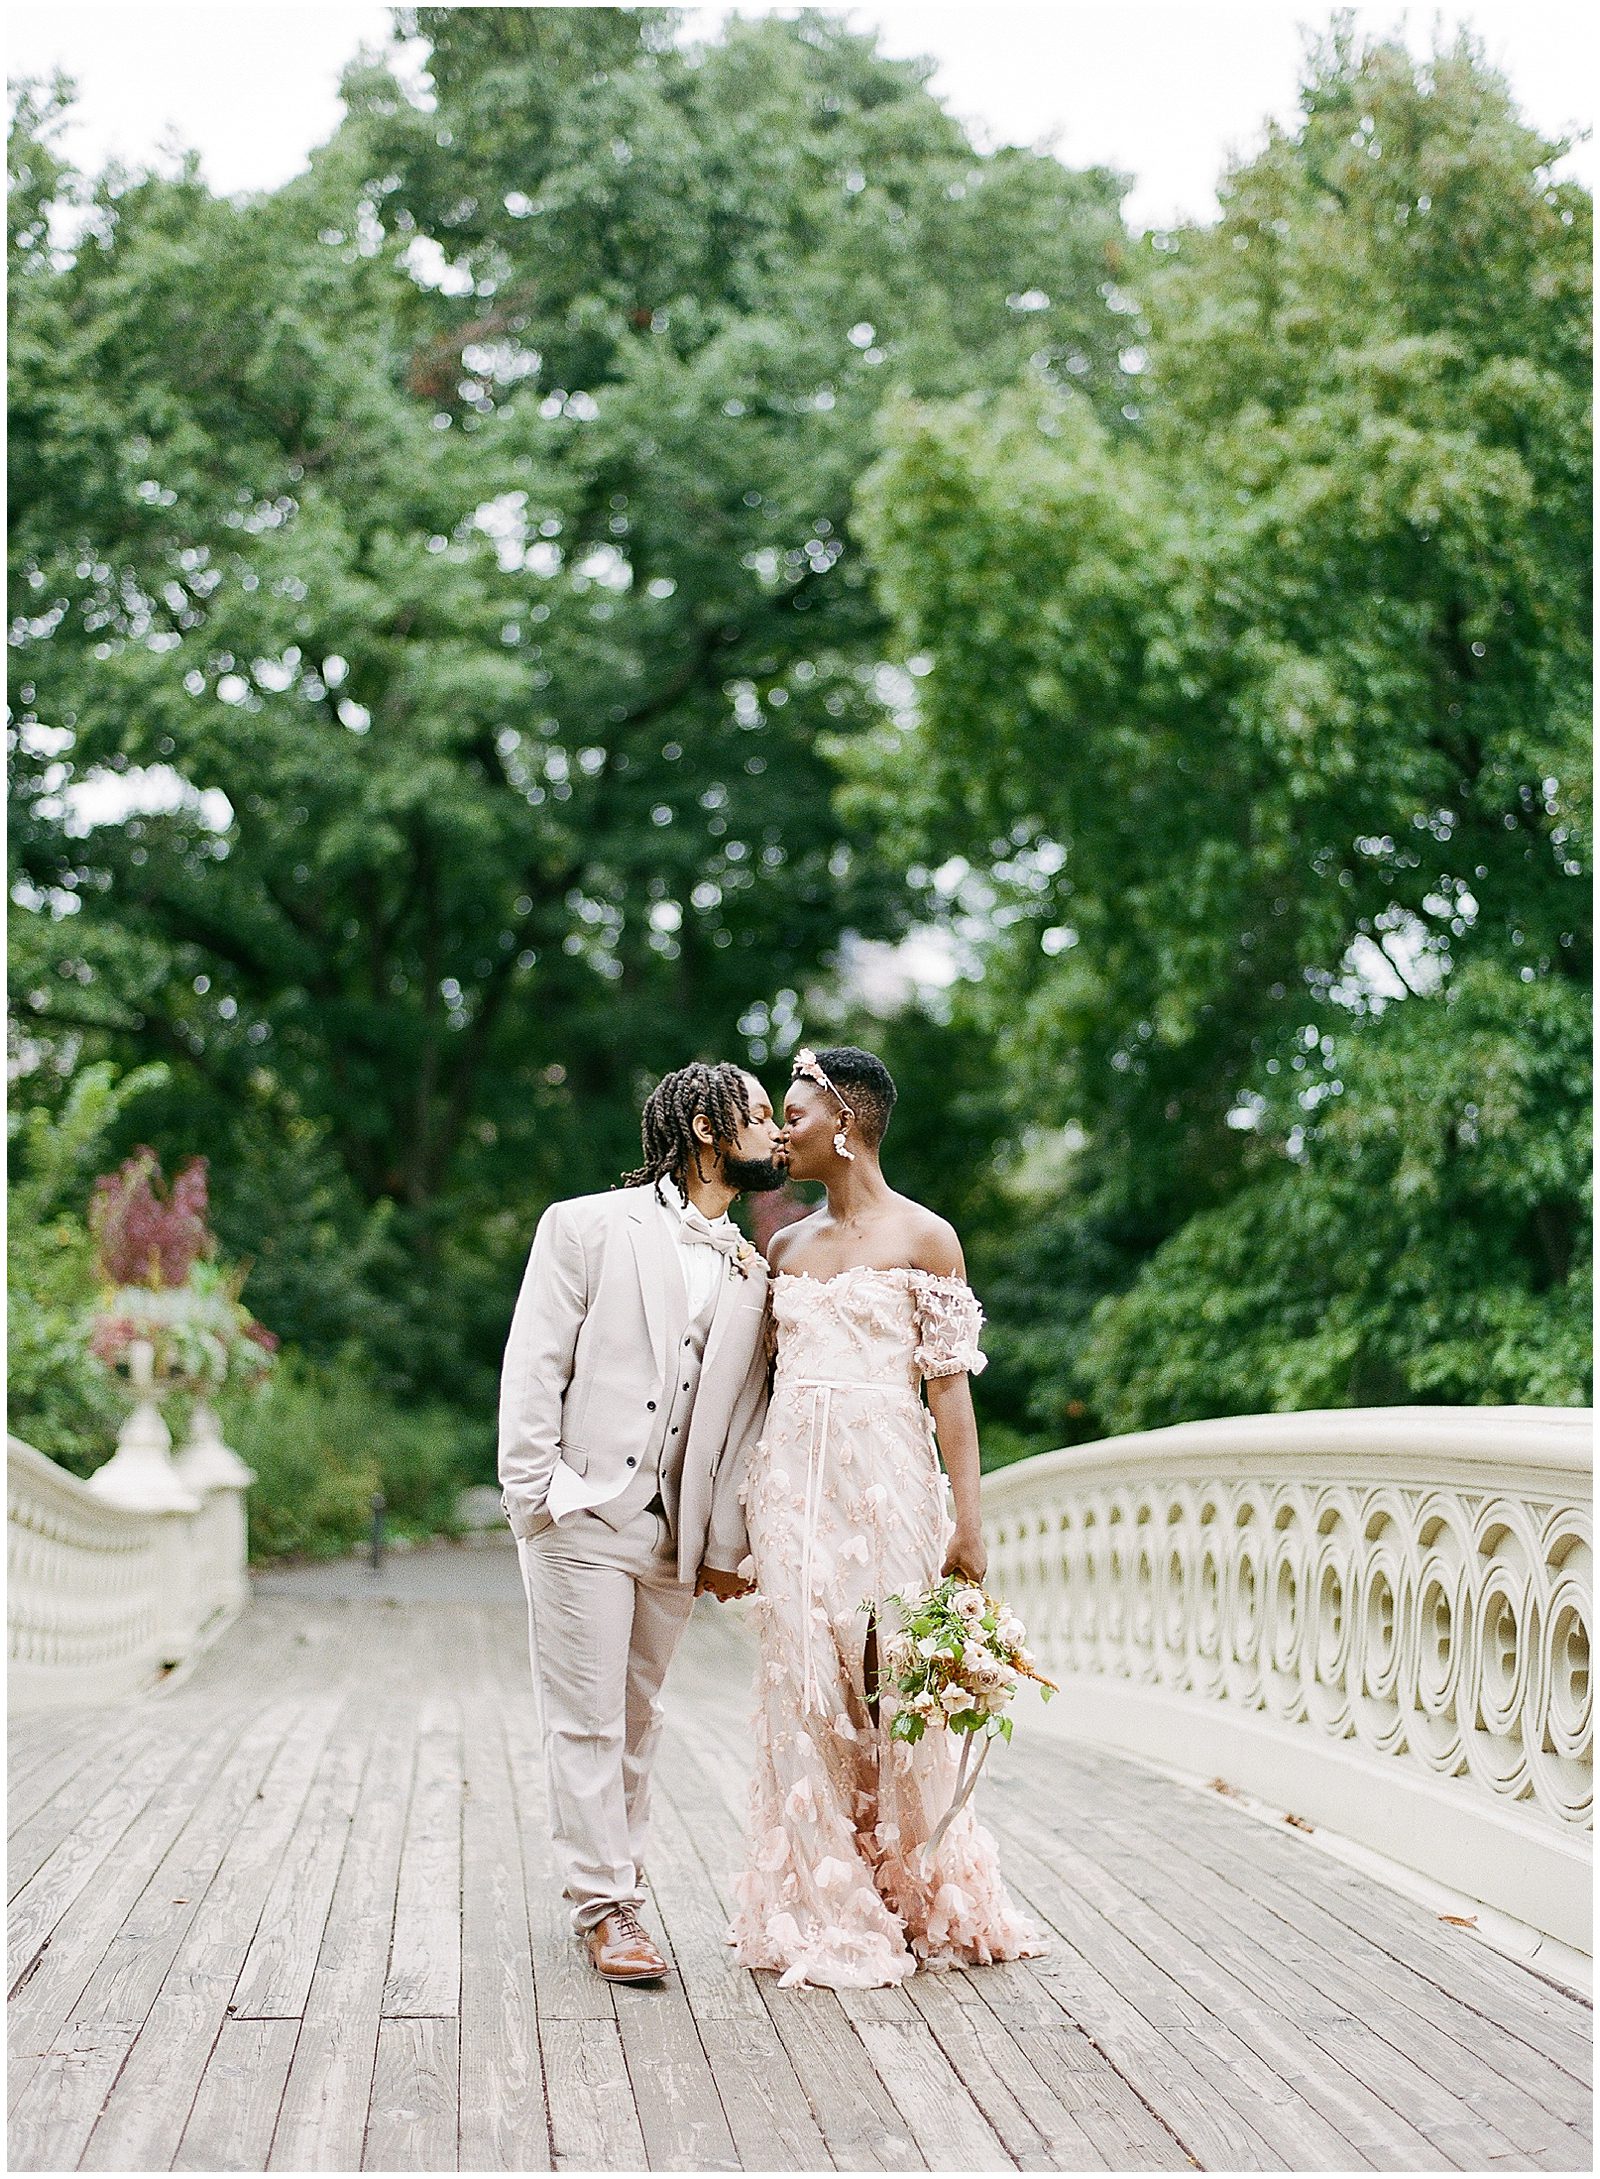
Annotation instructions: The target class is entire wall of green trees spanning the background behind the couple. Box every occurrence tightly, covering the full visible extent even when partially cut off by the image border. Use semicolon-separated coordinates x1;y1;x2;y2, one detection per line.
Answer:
9;7;1591;1445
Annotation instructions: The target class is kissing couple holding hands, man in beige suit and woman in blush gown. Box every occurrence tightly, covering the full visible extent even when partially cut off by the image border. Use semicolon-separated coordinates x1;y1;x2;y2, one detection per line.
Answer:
499;1046;1044;1989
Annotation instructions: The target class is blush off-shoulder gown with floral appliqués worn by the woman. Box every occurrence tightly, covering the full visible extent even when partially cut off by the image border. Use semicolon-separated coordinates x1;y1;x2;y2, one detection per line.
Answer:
728;1266;1044;1989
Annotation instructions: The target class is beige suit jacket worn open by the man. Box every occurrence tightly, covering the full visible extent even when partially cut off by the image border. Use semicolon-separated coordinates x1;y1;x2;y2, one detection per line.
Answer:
499;1188;767;1582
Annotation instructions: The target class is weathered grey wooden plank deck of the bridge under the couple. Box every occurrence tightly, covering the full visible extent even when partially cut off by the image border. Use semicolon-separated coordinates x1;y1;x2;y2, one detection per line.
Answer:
9;1547;1591;2172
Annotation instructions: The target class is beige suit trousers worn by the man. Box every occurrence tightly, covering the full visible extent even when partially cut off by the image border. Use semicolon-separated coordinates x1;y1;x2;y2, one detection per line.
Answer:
517;1512;695;1931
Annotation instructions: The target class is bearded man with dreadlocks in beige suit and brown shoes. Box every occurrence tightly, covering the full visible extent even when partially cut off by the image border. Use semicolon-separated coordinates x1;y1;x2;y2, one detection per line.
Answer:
499;1061;785;1983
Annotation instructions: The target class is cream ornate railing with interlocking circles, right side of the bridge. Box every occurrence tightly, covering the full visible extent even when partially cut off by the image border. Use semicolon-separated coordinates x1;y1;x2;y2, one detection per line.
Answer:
983;1408;1593;1952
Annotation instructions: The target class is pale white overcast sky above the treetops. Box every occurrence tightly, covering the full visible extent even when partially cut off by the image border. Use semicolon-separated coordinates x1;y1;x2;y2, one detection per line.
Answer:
4;0;1600;224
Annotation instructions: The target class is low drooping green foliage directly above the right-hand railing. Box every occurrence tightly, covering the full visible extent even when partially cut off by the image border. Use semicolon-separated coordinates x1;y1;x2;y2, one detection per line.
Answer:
1081;963;1591;1429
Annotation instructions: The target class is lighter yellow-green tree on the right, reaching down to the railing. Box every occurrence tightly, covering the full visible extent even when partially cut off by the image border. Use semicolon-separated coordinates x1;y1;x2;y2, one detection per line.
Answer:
848;28;1589;1436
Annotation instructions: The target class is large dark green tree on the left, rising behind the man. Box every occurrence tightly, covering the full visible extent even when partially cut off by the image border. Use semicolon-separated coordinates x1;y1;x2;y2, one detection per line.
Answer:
11;9;1123;1399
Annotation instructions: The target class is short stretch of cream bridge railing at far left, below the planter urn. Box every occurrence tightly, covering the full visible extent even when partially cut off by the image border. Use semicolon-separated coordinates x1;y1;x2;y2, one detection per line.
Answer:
7;1410;251;1708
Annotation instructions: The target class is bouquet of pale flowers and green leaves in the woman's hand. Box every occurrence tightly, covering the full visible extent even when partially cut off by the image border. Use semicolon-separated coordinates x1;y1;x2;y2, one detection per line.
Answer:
878;1573;1055;1741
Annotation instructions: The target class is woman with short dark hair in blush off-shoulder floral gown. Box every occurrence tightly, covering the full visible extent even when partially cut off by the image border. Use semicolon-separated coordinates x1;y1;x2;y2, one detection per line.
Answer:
728;1046;1044;1987
